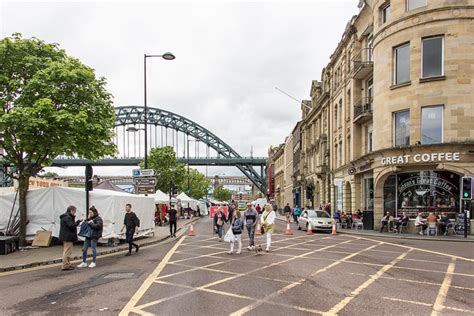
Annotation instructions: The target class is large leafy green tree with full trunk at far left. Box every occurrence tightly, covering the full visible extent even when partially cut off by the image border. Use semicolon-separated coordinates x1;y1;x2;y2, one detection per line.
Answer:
0;34;116;246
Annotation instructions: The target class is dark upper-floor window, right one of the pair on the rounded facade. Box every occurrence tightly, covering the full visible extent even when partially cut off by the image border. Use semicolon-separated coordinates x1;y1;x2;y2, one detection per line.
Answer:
421;36;444;78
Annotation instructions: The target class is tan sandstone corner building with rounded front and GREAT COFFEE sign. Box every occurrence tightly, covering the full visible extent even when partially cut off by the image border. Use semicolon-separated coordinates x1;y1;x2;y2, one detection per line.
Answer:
302;0;474;229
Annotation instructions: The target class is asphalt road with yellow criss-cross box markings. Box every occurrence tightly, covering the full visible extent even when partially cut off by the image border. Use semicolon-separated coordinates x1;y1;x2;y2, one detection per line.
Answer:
0;219;474;316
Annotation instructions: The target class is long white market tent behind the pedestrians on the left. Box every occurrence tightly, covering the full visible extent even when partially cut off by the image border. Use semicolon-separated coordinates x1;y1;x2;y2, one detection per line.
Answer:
0;187;155;240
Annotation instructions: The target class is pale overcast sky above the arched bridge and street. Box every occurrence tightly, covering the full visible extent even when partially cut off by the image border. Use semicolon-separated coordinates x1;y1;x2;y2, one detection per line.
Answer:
0;0;358;175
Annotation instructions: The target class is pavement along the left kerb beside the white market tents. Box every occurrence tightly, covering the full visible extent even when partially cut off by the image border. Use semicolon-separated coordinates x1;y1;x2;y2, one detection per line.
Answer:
0;218;199;273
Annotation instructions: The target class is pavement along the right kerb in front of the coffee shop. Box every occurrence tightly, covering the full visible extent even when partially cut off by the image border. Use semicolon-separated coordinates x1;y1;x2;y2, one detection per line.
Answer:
276;214;474;242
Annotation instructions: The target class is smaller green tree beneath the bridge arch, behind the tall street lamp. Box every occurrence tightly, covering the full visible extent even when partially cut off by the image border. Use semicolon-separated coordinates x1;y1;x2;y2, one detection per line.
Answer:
148;146;187;192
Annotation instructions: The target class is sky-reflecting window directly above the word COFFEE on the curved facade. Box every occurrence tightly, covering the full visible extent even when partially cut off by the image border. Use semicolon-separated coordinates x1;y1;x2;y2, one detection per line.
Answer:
421;105;443;144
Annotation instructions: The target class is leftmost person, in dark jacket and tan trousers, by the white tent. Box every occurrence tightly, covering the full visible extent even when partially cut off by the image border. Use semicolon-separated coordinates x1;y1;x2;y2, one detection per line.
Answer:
59;205;84;271
